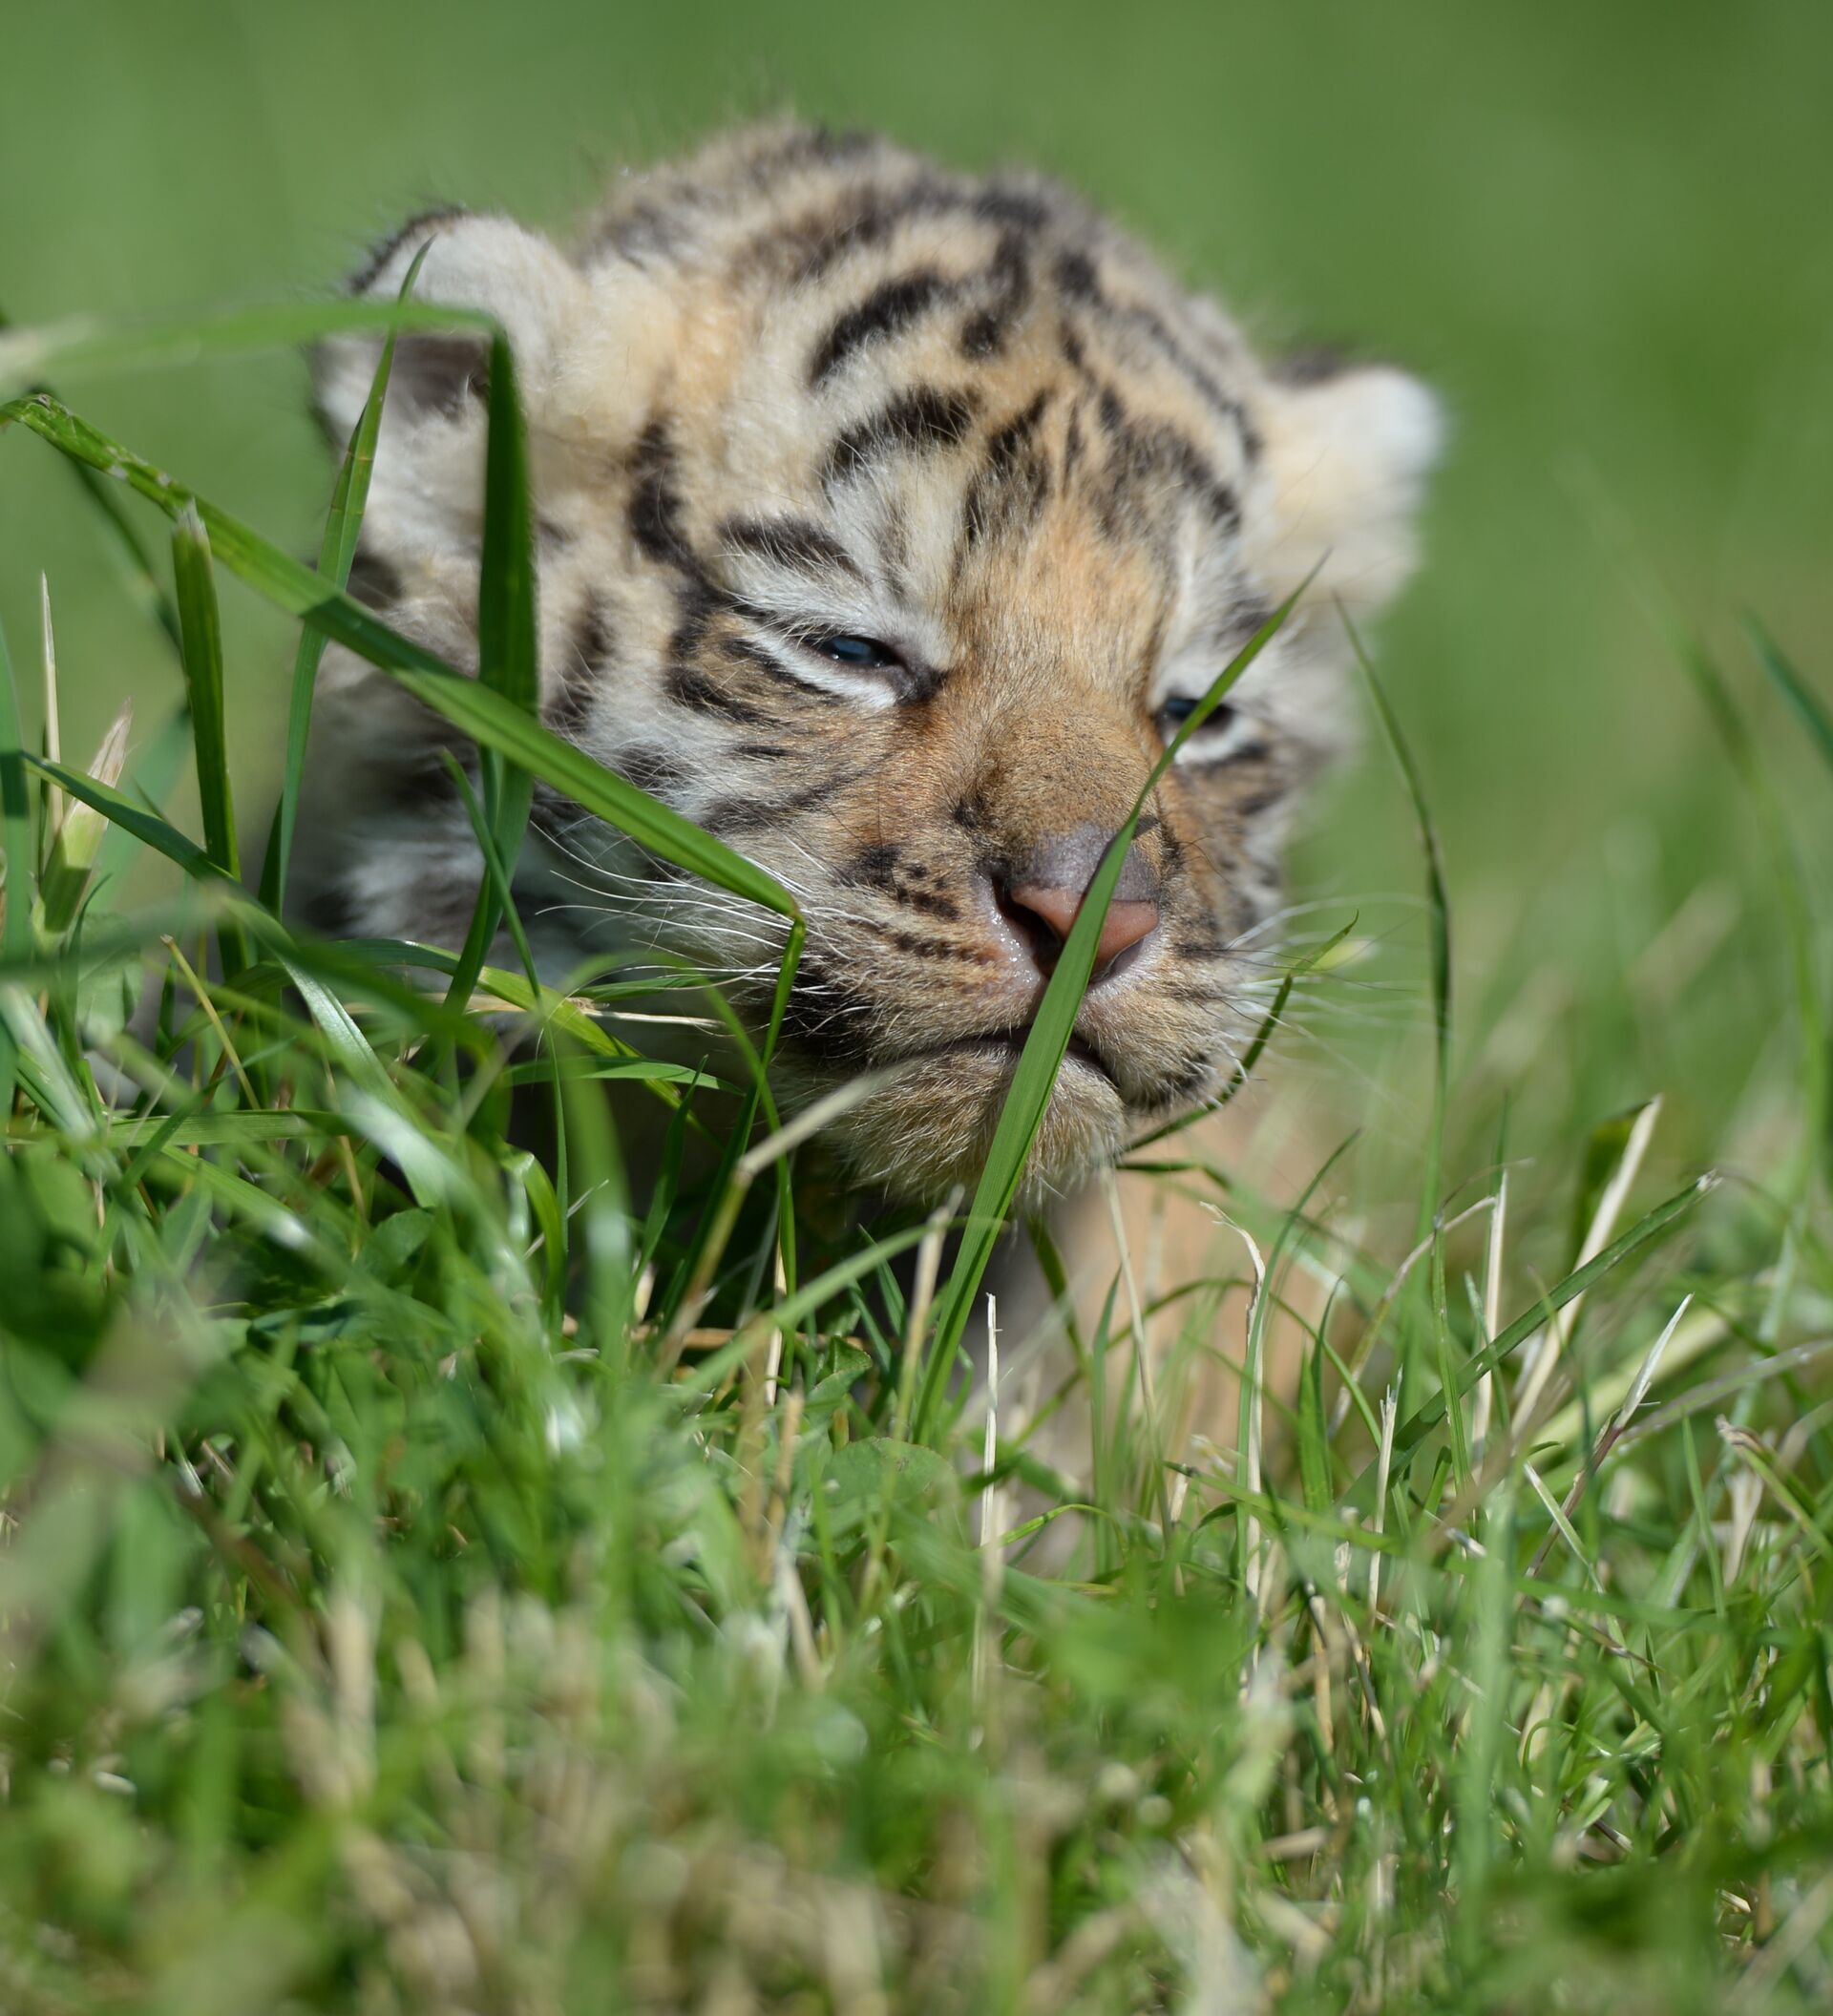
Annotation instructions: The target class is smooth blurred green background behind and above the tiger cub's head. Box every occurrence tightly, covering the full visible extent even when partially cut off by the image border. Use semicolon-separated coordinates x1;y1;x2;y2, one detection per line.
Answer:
0;0;1833;1161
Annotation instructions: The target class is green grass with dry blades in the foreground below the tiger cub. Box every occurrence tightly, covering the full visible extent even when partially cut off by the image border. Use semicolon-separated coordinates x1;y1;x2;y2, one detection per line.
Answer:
0;256;1833;2016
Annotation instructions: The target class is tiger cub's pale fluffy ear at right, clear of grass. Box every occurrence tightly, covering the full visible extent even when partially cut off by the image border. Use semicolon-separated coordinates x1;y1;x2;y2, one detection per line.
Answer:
1260;361;1445;615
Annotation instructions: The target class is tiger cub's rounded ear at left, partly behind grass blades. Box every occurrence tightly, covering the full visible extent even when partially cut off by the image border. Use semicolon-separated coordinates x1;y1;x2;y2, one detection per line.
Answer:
315;210;587;448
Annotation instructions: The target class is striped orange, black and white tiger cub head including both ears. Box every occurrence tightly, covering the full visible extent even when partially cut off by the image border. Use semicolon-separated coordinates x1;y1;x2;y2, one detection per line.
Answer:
312;129;1438;1195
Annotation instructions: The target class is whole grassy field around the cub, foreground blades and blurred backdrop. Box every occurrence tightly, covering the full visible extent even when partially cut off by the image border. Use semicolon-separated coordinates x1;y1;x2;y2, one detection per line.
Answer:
0;0;1833;2016
